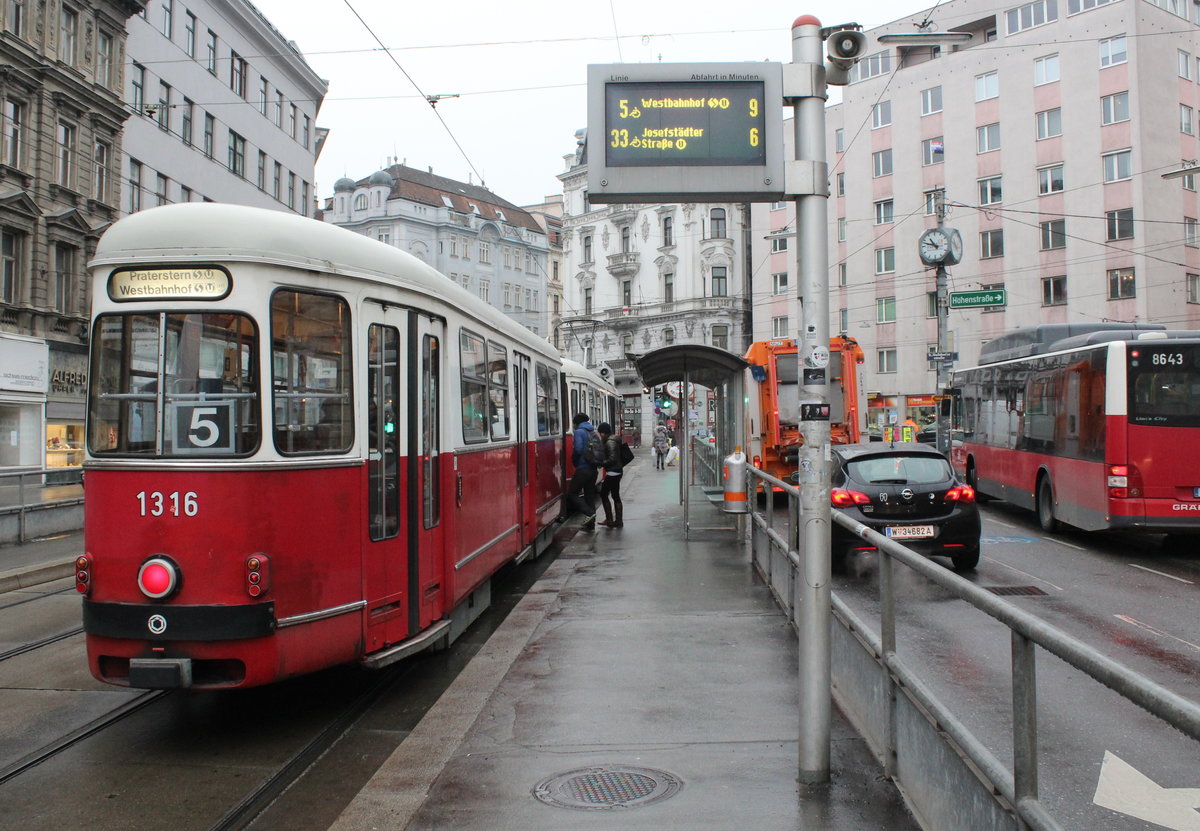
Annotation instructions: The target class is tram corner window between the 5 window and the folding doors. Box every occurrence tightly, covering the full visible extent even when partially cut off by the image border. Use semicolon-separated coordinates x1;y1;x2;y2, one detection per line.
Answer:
271;289;354;455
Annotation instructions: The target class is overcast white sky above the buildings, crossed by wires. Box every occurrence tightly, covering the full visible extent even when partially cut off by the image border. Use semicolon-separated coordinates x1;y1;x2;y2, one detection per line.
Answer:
243;0;926;205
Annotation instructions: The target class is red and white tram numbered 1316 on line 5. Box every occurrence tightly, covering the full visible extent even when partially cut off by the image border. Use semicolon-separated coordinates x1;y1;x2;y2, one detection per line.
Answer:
77;203;616;688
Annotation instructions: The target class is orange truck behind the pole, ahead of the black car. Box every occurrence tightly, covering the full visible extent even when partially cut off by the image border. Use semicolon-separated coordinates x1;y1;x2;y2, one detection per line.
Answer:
744;335;865;484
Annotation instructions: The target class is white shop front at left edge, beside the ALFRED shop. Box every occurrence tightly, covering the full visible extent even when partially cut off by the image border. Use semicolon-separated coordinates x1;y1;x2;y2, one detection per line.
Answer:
0;334;50;473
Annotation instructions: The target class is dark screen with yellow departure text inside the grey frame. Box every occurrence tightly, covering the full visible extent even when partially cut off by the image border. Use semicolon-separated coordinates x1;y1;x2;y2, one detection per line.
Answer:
605;80;767;167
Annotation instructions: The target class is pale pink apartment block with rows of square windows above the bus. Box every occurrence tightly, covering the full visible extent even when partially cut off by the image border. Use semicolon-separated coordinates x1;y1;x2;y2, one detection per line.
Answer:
754;0;1200;428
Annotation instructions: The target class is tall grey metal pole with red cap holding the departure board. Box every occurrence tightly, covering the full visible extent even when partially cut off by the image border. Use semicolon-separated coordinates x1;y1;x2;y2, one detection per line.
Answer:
785;14;833;784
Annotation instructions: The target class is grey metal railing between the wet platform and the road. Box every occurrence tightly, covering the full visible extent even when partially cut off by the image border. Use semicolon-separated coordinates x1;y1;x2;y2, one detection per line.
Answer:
749;467;1200;831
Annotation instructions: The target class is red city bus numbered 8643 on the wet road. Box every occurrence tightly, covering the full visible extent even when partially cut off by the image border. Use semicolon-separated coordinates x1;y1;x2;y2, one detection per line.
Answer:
950;323;1200;536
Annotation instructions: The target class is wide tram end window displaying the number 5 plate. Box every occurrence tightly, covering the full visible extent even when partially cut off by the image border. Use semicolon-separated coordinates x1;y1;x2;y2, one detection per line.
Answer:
88;313;260;458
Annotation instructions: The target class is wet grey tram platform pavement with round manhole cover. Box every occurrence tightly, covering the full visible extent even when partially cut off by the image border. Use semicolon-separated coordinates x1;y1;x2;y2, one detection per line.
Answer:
332;450;918;831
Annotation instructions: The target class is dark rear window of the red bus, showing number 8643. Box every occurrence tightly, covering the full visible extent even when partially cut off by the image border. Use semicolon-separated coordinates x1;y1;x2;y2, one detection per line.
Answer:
1128;343;1200;428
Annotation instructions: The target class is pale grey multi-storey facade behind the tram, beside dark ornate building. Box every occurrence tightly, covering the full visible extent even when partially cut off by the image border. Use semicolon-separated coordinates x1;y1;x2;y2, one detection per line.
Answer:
121;0;328;216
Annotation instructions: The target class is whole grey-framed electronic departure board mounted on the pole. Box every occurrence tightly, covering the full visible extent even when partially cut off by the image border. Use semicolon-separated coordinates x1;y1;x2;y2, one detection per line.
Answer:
578;62;784;203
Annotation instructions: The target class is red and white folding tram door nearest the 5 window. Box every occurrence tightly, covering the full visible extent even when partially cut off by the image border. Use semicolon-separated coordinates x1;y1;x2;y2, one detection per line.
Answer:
364;306;444;651
